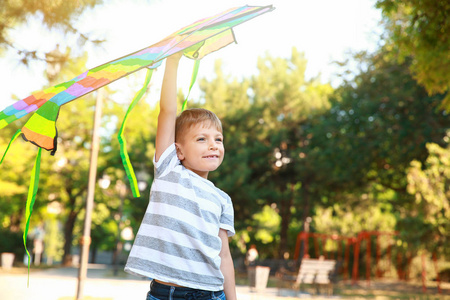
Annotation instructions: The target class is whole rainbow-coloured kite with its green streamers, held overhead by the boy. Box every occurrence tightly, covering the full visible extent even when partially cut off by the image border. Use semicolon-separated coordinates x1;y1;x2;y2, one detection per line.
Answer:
0;5;274;276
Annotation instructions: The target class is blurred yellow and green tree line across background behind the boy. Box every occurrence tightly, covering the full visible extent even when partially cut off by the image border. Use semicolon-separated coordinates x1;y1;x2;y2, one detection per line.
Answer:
0;38;450;266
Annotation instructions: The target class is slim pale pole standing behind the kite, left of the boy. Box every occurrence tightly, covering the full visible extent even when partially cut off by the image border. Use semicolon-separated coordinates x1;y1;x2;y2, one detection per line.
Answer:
76;89;103;300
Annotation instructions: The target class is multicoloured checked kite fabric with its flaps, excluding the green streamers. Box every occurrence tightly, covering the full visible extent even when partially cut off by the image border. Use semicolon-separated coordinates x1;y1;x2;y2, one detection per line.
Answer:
0;6;273;139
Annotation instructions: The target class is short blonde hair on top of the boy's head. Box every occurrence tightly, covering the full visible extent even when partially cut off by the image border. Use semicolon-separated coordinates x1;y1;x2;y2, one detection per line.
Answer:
175;108;223;142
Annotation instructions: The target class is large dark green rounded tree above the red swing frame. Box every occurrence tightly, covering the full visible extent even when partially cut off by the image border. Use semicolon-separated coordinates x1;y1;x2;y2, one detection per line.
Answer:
308;49;449;194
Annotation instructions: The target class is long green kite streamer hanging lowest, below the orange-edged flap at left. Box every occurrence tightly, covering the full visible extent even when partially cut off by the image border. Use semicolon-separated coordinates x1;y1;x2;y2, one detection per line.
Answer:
23;147;42;287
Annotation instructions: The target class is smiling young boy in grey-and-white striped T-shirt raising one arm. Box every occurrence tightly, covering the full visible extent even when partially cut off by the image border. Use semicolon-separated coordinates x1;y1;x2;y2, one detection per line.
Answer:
125;54;236;300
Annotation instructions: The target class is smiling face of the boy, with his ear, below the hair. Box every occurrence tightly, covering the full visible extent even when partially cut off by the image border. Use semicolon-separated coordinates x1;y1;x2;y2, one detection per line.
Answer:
176;123;225;178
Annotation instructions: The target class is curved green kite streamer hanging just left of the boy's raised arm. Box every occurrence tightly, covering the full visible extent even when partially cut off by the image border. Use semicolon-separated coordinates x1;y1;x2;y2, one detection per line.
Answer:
118;69;153;197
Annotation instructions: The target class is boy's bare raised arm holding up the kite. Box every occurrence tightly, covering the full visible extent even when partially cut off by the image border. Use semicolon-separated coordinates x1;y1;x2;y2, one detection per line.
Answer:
155;52;182;161
